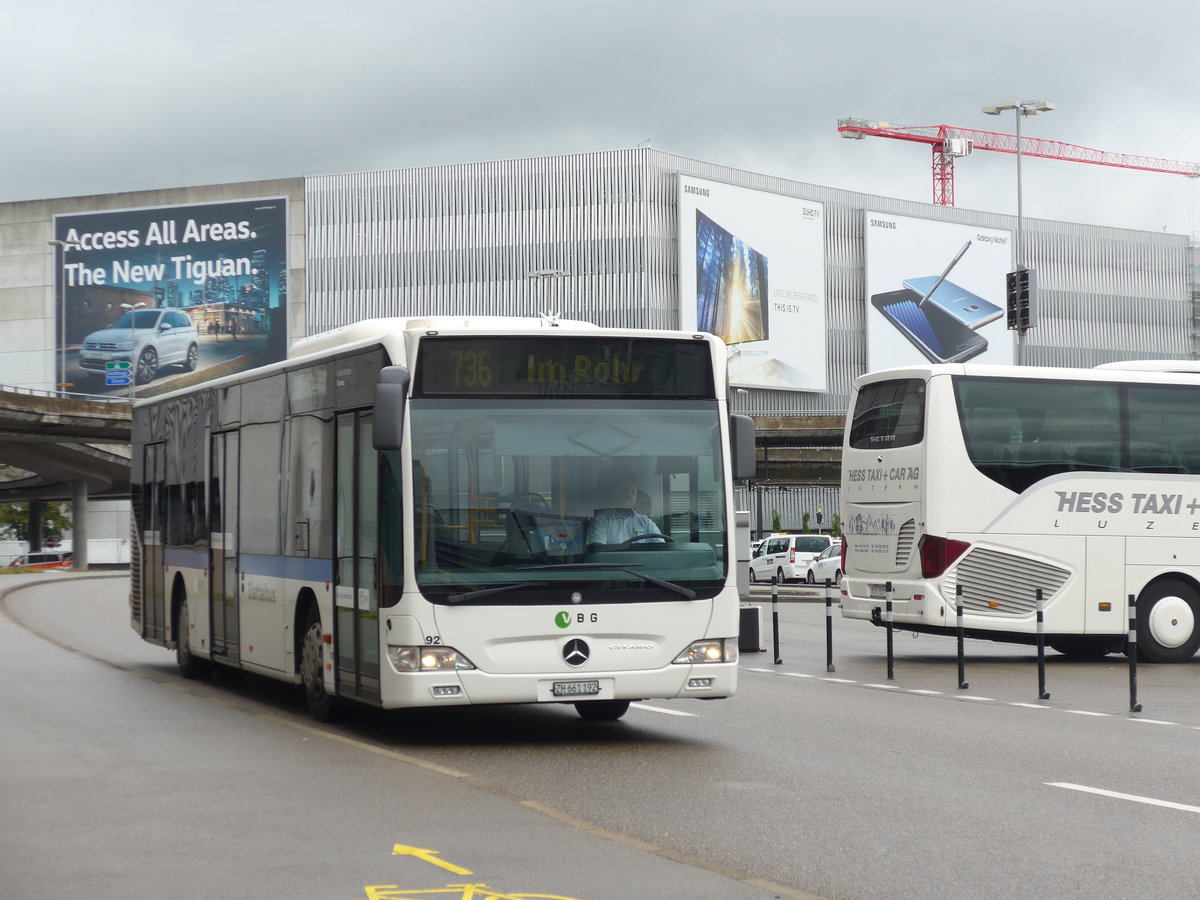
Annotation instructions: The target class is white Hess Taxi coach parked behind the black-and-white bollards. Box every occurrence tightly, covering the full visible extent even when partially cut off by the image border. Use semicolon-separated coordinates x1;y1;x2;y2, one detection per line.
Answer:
841;362;1200;662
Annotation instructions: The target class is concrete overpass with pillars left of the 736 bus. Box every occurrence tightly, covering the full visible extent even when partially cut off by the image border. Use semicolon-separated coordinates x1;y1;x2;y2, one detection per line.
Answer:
0;386;131;570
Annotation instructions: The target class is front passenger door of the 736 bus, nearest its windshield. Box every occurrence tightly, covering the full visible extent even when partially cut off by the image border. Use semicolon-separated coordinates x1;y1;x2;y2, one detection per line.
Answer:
334;410;379;702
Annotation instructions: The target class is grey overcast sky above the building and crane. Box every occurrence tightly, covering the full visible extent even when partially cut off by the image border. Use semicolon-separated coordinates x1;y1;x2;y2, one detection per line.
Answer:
0;0;1200;234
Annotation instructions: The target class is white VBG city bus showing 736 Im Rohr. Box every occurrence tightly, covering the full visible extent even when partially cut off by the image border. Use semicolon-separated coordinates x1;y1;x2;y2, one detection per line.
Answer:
131;318;754;719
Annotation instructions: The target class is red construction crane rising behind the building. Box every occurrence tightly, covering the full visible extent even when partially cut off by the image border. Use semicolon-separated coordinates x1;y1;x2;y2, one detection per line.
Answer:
838;119;1200;206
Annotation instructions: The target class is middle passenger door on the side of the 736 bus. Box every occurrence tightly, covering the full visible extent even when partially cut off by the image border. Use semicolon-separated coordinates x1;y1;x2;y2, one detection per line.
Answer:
209;431;240;662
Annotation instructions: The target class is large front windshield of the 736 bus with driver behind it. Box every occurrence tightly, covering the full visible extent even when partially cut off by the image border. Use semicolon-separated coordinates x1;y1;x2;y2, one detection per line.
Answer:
409;398;726;604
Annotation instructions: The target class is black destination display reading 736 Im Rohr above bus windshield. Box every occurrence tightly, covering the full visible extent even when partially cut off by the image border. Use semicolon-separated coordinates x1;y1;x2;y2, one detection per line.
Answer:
415;336;715;400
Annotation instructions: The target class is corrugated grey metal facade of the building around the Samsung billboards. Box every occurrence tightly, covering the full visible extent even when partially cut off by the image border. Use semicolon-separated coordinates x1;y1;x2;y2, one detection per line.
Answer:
305;148;1200;415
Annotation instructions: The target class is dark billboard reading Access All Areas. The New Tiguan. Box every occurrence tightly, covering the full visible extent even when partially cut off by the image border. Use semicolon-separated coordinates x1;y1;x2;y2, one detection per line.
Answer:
54;197;288;394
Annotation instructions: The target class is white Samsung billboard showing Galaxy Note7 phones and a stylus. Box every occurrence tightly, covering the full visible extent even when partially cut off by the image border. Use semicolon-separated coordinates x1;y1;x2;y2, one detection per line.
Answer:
864;210;1013;372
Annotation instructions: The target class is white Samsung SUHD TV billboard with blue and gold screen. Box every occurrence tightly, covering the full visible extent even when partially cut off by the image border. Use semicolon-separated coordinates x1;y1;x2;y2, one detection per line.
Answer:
679;175;826;391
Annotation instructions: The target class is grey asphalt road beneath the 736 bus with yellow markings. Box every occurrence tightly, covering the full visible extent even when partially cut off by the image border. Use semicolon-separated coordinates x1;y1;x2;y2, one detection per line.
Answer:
0;578;1200;900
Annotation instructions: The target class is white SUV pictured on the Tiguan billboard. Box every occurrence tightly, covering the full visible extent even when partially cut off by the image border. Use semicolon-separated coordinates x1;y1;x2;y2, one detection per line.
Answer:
79;308;200;384
